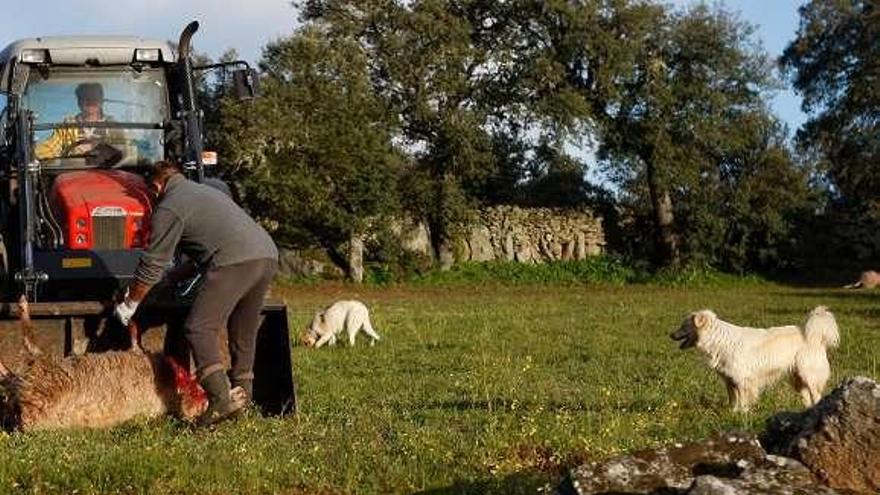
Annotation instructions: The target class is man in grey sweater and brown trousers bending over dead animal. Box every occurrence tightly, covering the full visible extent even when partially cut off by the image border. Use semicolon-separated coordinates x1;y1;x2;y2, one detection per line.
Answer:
115;162;278;425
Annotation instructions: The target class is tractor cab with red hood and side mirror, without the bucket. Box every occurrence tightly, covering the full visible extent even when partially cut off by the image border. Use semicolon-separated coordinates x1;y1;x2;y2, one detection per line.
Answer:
0;31;256;301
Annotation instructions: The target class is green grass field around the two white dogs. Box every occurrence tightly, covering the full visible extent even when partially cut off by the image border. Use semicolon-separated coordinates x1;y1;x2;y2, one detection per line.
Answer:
0;283;880;494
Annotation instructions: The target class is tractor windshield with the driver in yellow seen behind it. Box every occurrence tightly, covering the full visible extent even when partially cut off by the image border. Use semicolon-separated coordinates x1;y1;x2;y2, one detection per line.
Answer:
22;67;168;167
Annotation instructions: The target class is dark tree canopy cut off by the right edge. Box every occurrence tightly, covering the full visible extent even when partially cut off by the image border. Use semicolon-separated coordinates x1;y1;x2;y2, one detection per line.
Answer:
781;0;880;212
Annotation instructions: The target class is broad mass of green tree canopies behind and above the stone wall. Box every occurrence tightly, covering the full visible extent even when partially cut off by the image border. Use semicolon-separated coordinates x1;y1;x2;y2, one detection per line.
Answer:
210;0;836;276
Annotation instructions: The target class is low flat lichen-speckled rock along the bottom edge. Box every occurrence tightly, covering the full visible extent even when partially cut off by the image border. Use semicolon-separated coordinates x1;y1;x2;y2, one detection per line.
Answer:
557;434;837;495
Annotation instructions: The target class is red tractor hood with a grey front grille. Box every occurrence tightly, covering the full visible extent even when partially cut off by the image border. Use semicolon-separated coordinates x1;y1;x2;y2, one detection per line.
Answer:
50;170;151;249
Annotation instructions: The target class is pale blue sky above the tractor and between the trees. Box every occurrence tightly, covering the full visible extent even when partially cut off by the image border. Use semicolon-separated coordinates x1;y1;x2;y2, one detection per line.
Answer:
0;0;805;132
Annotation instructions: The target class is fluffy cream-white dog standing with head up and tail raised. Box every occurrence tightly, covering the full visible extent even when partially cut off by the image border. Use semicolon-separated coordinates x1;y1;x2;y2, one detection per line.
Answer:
670;306;840;411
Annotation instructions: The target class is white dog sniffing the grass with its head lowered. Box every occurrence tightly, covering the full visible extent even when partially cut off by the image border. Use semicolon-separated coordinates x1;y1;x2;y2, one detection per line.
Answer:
302;301;379;348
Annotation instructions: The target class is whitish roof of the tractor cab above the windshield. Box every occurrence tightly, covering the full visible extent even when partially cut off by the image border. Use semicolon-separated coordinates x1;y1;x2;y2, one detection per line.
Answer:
0;36;177;91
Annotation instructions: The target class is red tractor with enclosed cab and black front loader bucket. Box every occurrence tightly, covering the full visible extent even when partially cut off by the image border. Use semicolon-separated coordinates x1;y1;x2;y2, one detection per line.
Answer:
0;22;295;414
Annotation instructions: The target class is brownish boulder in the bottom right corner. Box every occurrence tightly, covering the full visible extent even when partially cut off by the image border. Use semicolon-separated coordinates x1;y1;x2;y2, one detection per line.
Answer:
761;377;880;493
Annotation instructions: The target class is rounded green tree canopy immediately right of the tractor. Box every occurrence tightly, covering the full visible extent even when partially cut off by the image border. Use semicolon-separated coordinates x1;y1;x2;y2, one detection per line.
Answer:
221;26;401;280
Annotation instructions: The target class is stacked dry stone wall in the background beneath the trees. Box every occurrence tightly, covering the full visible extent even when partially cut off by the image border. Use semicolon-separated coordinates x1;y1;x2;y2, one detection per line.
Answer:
440;206;605;266
